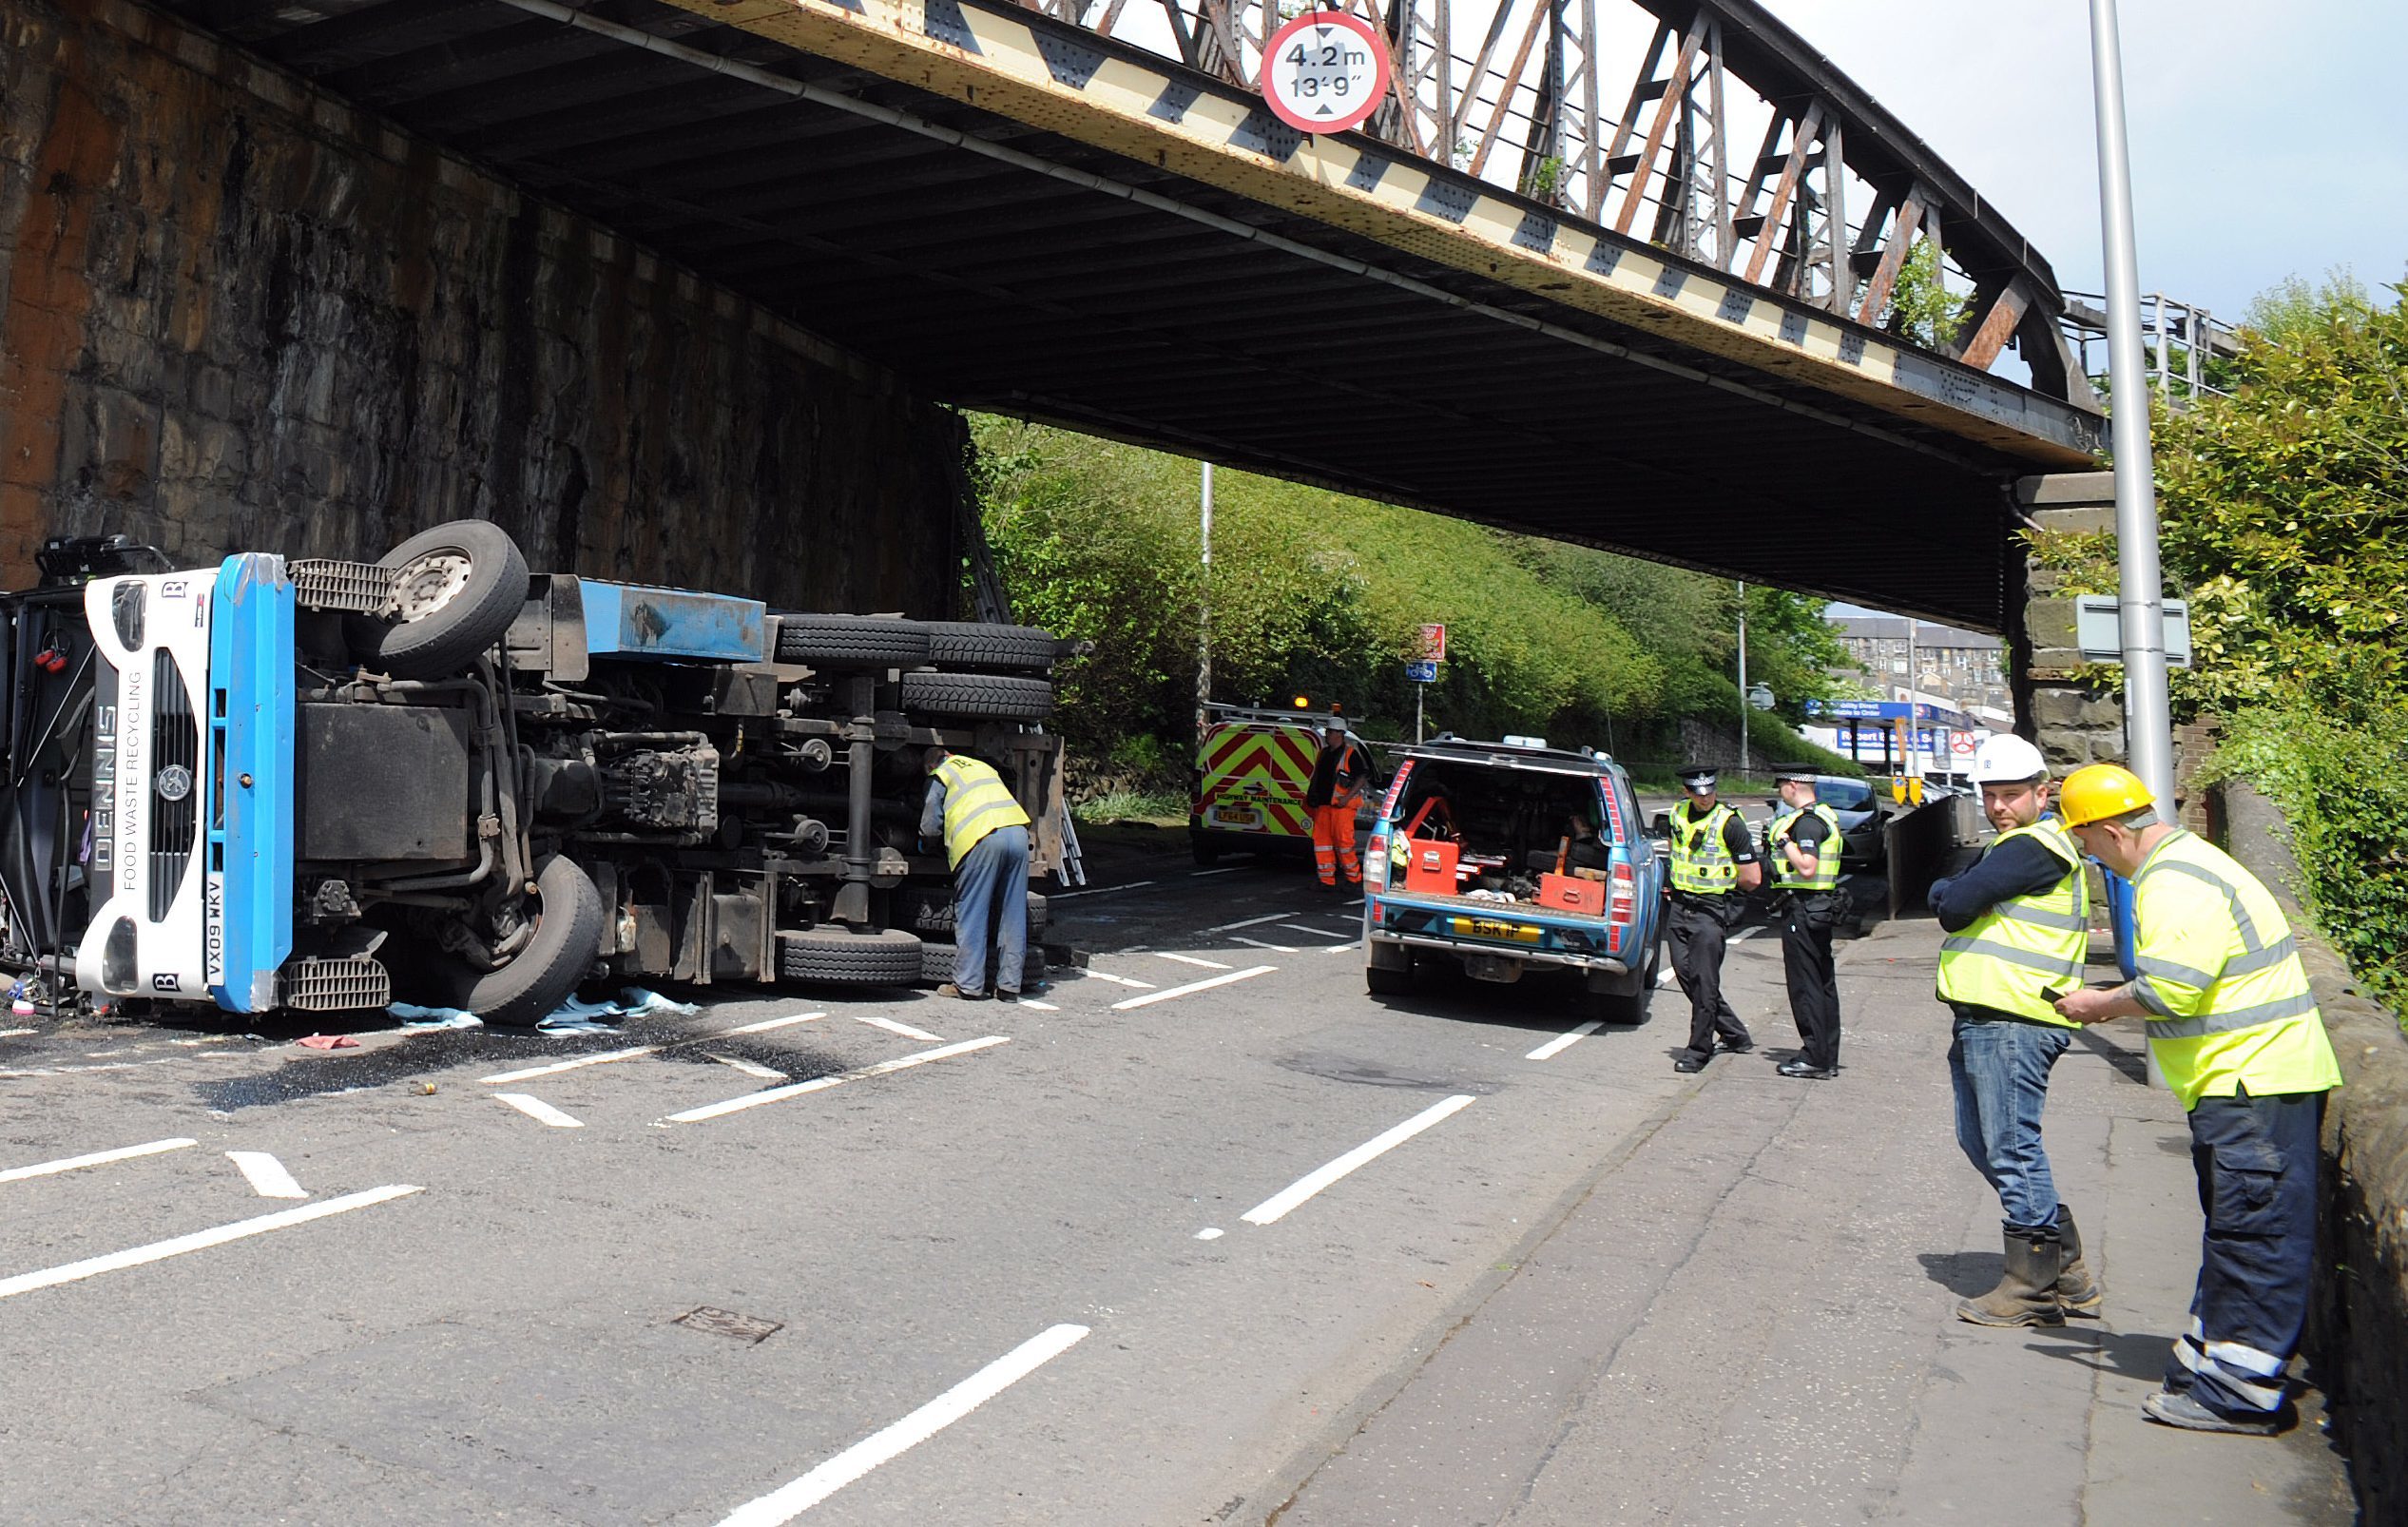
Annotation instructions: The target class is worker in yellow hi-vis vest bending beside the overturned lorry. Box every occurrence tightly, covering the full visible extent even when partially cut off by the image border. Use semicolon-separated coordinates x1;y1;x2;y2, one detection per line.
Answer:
920;746;1029;1002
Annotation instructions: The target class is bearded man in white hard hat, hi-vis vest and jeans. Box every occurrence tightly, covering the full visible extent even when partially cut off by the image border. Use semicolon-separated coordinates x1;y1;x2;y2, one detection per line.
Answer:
1931;735;2102;1324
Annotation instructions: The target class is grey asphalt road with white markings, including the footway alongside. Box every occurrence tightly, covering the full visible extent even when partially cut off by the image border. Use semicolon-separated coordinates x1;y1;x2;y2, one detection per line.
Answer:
0;833;2350;1527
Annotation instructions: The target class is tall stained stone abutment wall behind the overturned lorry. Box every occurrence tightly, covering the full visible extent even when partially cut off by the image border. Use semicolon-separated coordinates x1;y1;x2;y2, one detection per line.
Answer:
0;0;963;614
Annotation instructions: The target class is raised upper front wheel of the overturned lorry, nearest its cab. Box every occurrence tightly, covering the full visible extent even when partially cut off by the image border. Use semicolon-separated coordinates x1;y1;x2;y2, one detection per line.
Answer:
344;520;528;679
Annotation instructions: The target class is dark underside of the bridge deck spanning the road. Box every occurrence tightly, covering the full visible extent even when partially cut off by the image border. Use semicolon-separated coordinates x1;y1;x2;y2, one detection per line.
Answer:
171;0;2086;631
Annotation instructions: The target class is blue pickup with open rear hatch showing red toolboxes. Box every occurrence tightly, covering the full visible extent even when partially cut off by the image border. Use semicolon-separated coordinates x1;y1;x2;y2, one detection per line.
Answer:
1363;737;1666;1024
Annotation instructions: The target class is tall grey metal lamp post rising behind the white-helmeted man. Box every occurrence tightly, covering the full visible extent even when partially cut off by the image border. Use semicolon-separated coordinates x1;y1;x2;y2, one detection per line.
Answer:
2090;0;2174;817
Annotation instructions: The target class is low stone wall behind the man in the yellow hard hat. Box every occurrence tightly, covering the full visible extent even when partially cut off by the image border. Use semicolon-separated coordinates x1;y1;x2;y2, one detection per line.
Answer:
2213;781;2408;1522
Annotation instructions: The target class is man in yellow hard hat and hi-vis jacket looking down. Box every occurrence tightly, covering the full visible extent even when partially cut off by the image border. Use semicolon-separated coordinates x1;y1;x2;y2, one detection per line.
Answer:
2056;764;2341;1436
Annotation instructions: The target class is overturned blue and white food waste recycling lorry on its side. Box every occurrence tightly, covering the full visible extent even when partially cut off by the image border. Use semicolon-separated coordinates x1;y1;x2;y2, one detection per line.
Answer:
0;520;1062;1024
